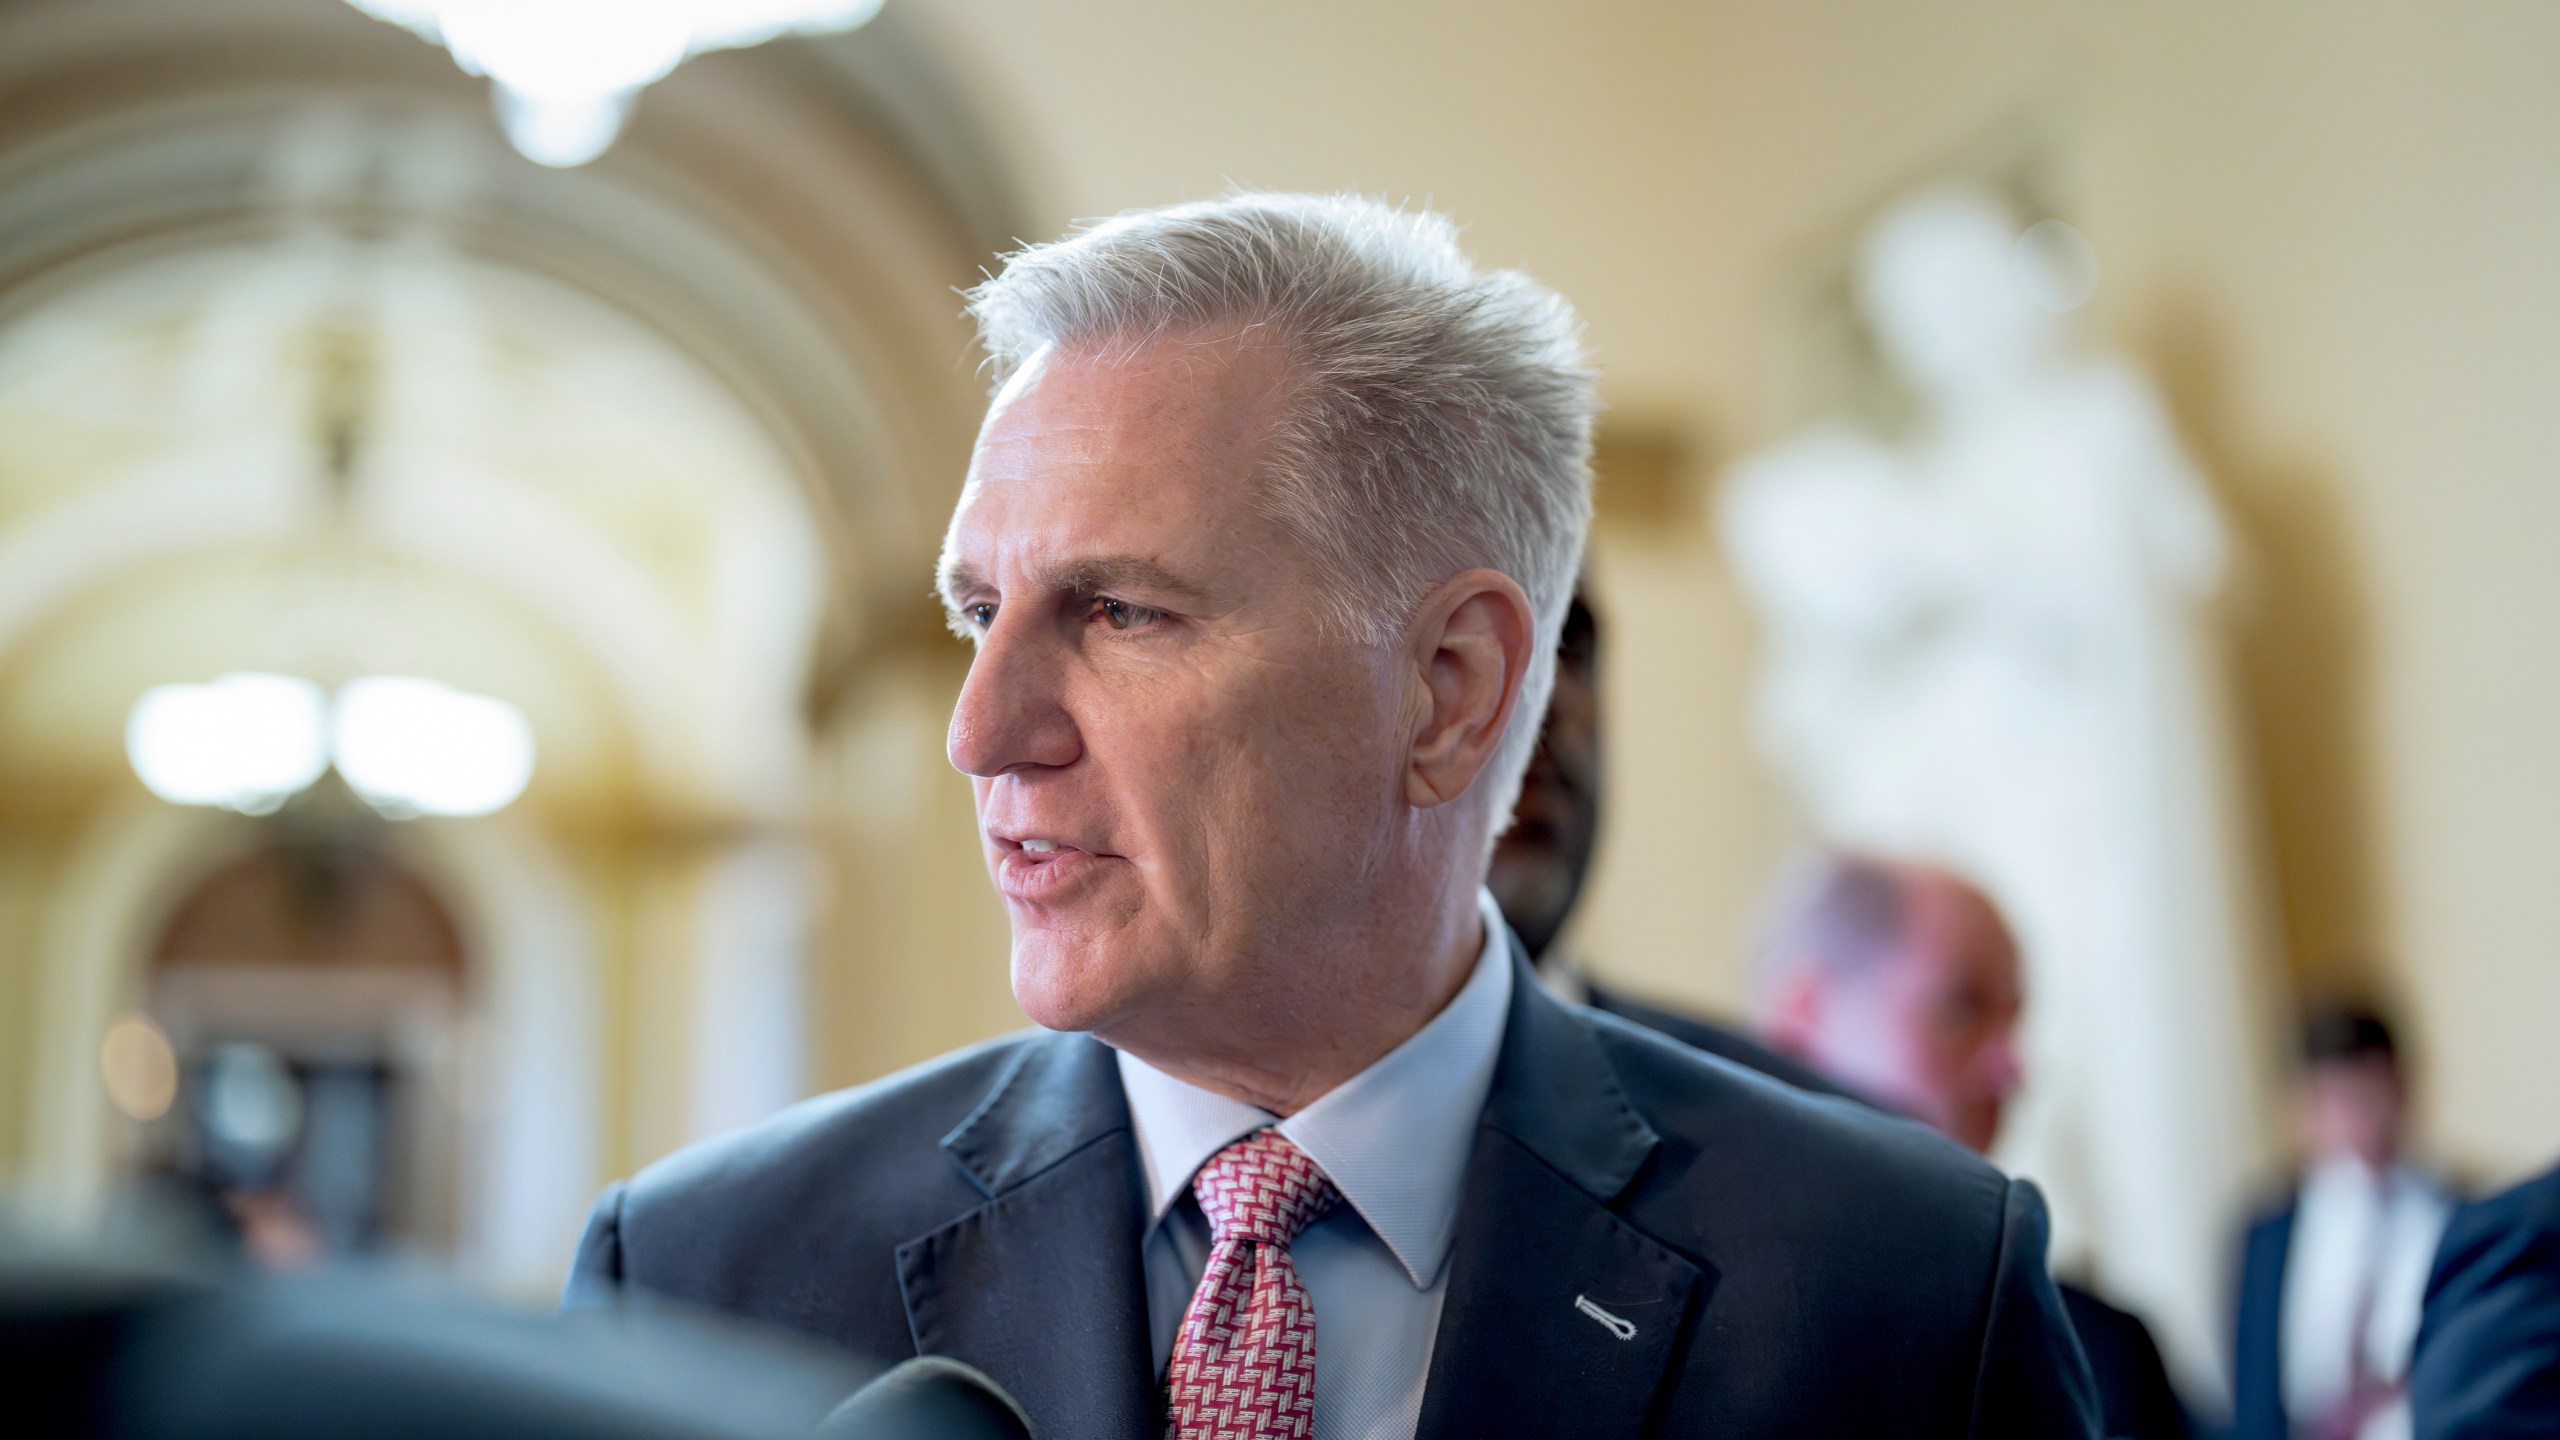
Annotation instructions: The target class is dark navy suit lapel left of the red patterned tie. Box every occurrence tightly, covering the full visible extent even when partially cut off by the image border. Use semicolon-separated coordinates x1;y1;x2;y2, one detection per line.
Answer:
899;1035;1157;1440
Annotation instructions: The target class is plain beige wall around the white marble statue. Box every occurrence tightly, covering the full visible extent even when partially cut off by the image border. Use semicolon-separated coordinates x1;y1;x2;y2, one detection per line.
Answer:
932;0;2560;1174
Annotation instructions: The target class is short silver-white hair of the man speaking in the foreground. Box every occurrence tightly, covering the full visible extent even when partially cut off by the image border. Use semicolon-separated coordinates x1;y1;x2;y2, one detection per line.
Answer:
968;195;1597;830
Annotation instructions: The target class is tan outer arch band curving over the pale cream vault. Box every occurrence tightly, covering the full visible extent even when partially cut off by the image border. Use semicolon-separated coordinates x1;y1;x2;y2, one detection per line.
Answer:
0;0;1019;707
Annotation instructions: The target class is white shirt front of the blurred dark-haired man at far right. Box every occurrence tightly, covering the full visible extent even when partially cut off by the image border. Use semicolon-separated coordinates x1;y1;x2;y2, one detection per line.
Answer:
2276;1158;2452;1440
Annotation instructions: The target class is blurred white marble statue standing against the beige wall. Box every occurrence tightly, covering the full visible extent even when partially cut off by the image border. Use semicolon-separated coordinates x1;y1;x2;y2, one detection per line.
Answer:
1723;190;2263;1384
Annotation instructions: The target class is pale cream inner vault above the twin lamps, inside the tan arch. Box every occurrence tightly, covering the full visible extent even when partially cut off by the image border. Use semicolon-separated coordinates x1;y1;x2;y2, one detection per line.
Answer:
0;231;824;812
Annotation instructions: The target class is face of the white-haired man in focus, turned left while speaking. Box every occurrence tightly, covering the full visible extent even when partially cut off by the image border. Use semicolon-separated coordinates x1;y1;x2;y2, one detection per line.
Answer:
942;341;1408;1038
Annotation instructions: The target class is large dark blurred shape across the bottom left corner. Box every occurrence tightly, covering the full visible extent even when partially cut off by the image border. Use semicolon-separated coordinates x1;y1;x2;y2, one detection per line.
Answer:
0;1245;870;1440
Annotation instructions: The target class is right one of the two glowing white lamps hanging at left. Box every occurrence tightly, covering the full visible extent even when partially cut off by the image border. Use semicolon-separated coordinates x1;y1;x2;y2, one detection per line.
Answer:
330;674;532;815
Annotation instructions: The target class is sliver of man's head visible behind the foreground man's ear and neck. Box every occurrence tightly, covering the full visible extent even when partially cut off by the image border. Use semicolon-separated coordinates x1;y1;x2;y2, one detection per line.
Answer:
1485;594;1600;956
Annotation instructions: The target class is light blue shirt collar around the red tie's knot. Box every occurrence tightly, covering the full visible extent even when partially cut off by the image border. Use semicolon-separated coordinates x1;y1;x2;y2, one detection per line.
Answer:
1119;892;1510;1289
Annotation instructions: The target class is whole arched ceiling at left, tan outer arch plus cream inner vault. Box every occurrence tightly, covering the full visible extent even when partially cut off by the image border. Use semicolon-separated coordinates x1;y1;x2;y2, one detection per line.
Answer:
0;0;1009;815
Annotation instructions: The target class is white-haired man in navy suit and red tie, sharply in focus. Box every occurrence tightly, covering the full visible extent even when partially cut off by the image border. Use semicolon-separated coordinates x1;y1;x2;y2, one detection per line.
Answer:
571;195;2092;1440
